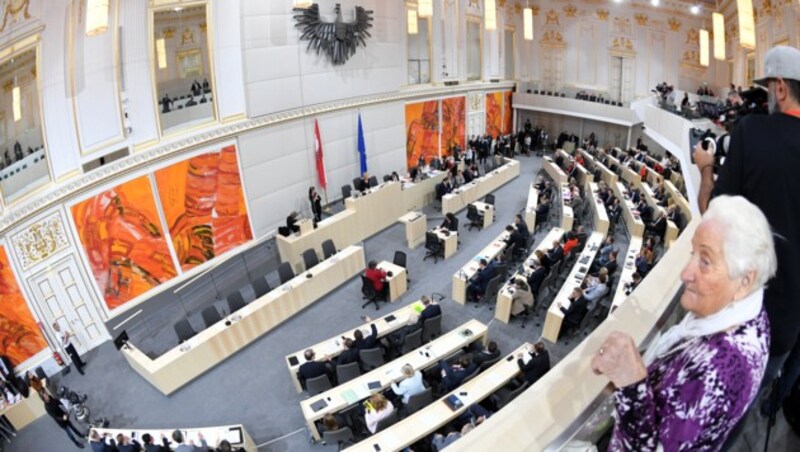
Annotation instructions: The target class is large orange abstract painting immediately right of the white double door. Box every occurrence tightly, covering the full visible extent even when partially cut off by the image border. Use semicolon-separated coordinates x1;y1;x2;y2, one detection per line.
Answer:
71;176;176;309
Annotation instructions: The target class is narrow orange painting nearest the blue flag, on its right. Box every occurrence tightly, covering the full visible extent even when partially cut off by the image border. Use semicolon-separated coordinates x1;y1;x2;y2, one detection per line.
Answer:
406;100;439;169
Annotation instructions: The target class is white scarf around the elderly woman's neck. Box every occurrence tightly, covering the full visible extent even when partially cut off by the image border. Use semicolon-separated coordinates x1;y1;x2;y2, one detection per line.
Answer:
644;288;764;366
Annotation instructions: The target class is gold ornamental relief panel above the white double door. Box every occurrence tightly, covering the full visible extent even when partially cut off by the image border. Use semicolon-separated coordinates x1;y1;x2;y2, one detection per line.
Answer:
11;212;69;270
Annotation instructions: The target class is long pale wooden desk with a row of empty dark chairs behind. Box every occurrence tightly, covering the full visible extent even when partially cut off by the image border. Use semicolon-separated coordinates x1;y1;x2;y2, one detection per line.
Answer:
121;246;366;395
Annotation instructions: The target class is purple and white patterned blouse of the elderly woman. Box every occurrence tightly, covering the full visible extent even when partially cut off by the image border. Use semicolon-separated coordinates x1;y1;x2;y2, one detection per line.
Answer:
609;308;769;451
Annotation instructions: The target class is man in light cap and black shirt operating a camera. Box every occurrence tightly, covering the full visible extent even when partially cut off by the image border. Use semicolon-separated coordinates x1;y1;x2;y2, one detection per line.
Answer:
693;46;800;411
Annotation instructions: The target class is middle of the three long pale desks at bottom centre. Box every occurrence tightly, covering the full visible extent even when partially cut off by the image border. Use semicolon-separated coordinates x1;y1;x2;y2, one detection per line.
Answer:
300;319;489;441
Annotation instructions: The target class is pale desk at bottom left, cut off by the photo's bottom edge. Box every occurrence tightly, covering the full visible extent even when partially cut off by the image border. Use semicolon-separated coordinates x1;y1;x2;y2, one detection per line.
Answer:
94;424;258;452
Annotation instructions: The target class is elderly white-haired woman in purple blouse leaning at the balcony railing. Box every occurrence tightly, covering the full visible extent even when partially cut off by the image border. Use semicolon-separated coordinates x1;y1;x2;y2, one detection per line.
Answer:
592;196;777;451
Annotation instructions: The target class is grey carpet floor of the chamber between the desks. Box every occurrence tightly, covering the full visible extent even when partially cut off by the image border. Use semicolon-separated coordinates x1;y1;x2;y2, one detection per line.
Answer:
5;157;797;452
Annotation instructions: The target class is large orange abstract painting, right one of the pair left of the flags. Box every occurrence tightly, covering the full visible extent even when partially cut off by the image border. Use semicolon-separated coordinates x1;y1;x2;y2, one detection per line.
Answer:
155;145;253;270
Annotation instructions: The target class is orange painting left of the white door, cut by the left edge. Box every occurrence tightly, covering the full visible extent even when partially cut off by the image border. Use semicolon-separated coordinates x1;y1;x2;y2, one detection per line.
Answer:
0;246;47;366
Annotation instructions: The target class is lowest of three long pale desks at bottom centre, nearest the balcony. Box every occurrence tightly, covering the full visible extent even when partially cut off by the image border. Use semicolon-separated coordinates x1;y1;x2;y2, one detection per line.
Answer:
348;343;532;452
